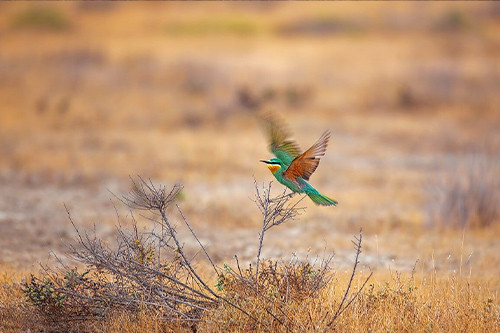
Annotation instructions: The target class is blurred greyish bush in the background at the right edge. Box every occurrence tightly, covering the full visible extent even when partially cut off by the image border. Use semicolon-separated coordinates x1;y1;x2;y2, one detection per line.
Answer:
427;155;500;227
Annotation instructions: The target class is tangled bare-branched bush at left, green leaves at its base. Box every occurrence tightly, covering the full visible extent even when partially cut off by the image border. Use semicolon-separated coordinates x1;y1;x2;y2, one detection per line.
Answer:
24;176;218;328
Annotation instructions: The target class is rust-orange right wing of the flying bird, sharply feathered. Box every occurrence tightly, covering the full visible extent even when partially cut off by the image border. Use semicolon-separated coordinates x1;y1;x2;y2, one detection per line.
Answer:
283;131;330;181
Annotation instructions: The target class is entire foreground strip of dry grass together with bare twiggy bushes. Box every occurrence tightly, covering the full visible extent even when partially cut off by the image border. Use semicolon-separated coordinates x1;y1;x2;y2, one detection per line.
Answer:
0;179;500;332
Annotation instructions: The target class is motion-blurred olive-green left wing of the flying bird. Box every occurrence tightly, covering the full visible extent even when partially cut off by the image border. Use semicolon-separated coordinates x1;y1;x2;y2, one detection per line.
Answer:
264;115;300;166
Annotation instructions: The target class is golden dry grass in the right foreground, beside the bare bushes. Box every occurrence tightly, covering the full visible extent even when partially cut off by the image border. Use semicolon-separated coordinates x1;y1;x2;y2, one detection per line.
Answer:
199;272;500;332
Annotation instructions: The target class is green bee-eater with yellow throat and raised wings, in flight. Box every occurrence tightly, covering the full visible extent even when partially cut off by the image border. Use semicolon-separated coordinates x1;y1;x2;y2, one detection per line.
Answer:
261;118;337;206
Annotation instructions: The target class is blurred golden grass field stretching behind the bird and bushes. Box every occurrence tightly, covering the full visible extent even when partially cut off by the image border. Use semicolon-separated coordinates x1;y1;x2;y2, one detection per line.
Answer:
0;2;500;332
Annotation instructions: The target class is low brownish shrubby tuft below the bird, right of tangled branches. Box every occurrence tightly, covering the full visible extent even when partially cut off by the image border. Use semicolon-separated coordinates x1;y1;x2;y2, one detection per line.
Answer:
202;258;333;331
